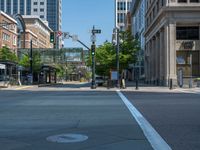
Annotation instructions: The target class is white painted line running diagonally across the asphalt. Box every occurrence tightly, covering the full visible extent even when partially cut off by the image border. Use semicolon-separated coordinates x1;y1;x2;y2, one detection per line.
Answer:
117;90;172;150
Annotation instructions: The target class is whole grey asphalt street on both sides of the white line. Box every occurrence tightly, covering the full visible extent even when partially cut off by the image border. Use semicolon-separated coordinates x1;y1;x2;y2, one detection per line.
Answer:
0;84;200;150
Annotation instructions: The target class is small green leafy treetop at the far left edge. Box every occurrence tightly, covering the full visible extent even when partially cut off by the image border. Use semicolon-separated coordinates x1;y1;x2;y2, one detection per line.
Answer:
0;46;18;62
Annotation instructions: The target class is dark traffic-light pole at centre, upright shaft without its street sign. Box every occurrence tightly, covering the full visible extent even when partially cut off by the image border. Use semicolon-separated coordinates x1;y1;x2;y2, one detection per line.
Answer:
91;26;96;89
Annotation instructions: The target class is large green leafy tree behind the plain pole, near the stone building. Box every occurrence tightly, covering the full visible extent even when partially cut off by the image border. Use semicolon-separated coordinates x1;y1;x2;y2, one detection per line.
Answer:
91;31;140;76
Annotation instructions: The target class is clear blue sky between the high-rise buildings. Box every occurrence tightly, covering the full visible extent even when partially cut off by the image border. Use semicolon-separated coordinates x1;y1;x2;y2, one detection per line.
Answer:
62;0;114;47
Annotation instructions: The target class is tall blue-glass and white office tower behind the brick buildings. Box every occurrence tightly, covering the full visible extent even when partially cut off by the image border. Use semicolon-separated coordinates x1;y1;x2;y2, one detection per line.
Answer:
0;0;62;48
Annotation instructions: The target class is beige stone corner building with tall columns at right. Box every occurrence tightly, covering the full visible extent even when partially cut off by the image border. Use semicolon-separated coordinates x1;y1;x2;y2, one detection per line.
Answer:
144;0;200;86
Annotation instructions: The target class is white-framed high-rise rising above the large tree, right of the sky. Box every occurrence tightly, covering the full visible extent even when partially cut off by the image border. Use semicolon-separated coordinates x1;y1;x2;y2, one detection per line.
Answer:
115;0;132;31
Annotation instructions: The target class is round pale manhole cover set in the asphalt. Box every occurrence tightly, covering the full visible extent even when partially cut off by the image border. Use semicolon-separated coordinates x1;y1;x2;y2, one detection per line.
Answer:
47;134;88;143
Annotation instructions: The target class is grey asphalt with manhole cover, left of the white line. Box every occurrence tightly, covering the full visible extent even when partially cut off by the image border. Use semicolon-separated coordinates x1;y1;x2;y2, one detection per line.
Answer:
0;88;152;150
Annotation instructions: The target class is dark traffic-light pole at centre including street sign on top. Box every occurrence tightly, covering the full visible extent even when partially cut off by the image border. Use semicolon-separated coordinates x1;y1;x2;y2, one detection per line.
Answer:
91;26;101;89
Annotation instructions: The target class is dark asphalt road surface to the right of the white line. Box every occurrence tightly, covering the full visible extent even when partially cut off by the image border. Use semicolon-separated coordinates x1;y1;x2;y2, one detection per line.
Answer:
124;92;200;150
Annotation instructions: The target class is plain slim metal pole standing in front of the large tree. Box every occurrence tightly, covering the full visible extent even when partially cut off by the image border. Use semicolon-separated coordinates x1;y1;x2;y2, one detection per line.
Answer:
116;28;120;88
